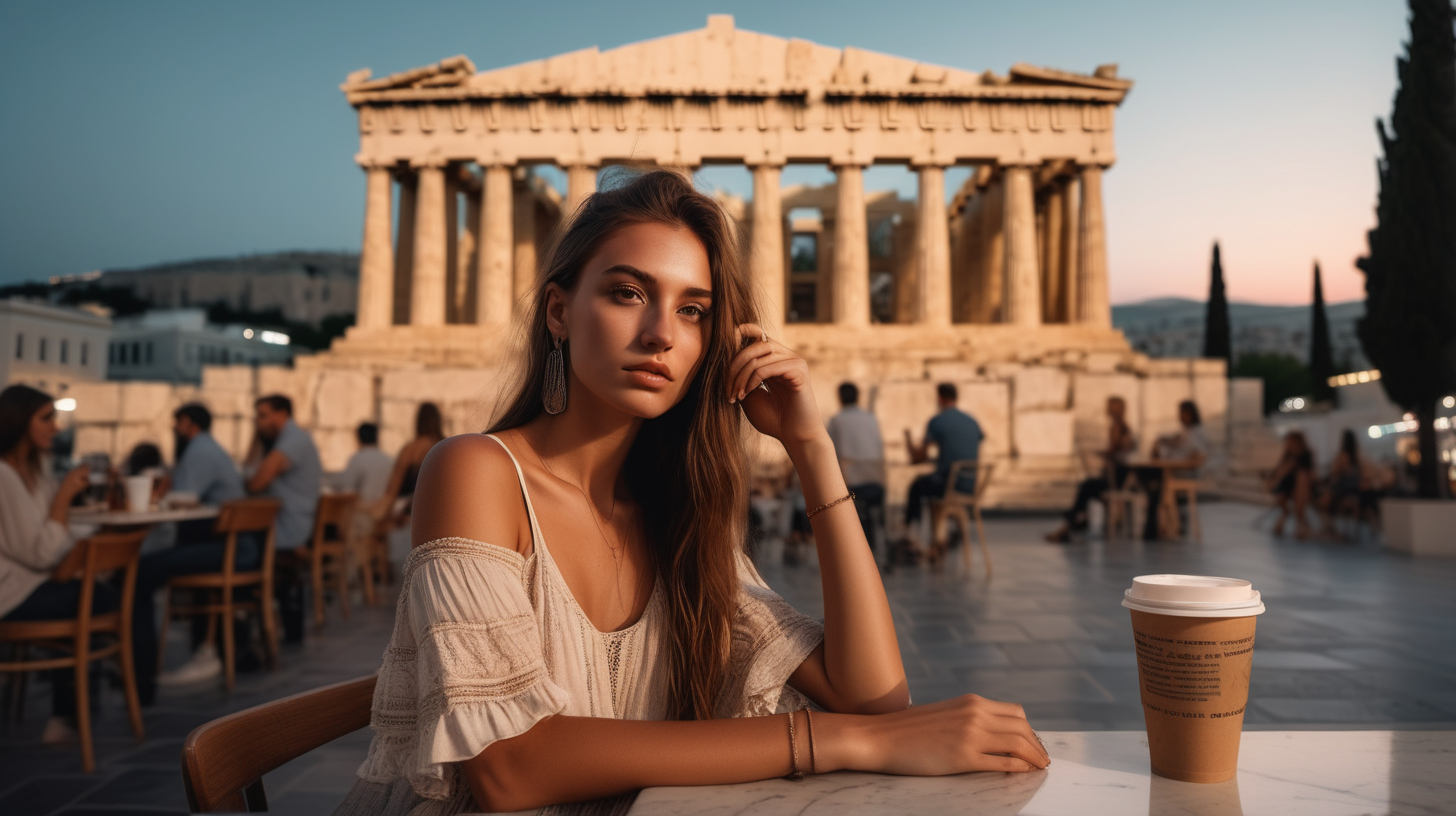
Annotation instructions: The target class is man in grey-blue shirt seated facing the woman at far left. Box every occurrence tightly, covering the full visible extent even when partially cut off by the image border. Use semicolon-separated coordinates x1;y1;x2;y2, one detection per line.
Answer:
131;402;247;705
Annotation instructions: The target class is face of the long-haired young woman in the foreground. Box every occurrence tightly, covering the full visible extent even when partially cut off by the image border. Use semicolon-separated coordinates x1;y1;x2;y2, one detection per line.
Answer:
546;223;713;418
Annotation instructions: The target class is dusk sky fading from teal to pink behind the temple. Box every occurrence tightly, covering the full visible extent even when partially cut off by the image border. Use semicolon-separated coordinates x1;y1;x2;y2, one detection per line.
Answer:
0;0;1408;303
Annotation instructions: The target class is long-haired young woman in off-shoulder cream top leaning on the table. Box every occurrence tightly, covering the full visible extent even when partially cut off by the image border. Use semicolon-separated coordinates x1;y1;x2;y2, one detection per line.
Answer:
339;172;1048;815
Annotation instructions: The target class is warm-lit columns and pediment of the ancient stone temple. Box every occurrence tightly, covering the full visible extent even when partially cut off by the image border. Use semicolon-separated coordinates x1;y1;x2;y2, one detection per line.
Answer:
335;15;1131;364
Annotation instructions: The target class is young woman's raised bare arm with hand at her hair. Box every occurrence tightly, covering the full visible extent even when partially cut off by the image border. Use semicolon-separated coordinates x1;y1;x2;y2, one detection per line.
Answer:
728;325;910;714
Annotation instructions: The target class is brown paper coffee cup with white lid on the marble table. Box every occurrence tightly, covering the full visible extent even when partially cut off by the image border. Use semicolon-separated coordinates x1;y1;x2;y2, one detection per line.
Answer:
1123;576;1264;782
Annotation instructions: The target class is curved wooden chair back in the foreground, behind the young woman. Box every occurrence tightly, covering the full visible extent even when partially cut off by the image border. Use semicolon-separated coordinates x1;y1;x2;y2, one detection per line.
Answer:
182;675;376;813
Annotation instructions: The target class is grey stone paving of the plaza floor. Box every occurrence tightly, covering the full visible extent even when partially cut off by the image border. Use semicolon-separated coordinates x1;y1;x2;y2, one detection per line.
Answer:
0;504;1456;816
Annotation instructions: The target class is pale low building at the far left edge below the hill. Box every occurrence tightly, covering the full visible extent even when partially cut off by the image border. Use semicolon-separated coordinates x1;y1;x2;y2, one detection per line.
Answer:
0;297;112;396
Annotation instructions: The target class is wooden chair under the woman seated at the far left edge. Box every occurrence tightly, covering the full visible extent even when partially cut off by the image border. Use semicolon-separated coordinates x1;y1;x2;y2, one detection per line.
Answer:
0;527;149;774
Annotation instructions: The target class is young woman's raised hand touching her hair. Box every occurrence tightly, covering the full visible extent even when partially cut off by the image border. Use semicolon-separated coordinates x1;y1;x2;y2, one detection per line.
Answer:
725;323;827;447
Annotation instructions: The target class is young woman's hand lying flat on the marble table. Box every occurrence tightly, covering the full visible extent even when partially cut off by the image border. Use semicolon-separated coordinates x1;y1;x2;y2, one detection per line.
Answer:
814;694;1051;777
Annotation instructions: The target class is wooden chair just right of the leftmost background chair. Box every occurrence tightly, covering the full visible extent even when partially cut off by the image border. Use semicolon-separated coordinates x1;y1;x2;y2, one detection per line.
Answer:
157;498;280;691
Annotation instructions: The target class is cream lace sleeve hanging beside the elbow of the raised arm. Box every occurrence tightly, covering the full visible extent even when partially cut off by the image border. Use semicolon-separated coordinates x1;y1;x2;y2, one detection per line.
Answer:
718;557;824;717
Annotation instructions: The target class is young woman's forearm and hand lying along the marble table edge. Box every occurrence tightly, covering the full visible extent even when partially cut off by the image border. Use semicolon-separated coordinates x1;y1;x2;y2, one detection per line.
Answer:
460;695;1051;812
